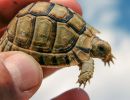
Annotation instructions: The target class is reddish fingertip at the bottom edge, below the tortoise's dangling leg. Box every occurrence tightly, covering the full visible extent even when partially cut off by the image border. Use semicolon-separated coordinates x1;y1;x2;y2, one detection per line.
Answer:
52;88;90;100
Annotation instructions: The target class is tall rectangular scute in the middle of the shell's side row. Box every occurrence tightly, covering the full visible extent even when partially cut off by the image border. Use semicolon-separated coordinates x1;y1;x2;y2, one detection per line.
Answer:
30;16;56;52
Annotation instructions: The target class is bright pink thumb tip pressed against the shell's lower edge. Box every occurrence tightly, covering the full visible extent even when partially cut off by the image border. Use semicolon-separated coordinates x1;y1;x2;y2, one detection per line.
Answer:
0;51;43;99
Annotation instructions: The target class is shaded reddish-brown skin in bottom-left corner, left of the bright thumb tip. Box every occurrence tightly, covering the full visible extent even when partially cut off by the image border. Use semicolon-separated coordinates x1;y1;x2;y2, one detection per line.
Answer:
0;59;20;100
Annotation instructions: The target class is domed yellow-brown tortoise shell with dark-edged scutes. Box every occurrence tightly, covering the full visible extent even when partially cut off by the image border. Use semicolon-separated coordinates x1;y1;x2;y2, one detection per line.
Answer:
0;2;94;66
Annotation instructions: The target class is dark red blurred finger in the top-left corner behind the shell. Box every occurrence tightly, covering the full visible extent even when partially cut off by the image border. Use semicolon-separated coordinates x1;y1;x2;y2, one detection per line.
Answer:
0;0;49;22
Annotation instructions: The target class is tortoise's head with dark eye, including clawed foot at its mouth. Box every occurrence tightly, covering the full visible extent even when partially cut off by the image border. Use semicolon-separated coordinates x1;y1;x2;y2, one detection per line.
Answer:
90;37;114;66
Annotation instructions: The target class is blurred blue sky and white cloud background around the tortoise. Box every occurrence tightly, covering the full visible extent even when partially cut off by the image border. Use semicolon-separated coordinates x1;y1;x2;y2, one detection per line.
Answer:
31;0;130;100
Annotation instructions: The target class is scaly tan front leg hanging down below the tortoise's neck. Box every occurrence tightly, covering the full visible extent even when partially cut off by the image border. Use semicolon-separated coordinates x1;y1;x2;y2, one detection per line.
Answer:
77;58;94;87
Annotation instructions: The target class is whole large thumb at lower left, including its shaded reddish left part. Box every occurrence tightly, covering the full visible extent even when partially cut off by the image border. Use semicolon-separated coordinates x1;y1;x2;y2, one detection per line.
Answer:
0;51;43;100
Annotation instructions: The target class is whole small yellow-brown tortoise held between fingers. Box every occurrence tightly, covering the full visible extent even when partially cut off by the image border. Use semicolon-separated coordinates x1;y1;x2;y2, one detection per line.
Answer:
0;2;113;86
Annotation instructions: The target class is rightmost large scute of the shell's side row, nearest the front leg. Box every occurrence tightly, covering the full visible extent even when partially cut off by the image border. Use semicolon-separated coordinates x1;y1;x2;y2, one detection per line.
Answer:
53;23;79;53
